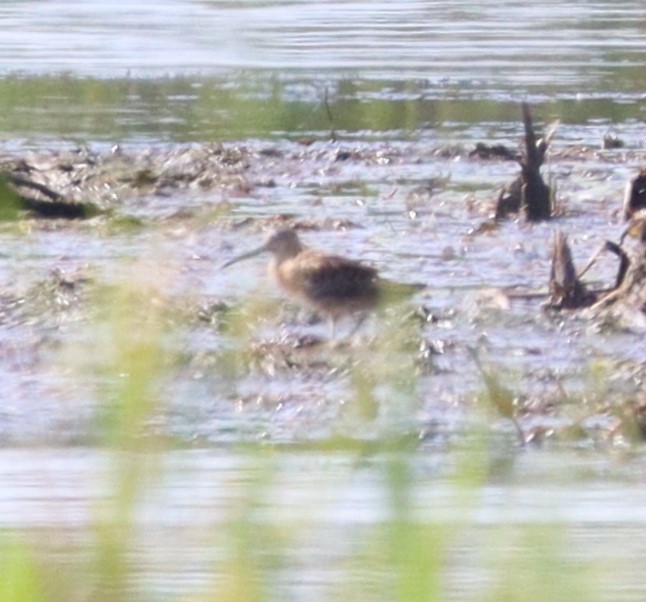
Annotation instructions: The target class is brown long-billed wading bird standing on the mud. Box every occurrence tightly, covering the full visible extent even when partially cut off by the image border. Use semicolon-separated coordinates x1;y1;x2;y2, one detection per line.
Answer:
222;228;424;338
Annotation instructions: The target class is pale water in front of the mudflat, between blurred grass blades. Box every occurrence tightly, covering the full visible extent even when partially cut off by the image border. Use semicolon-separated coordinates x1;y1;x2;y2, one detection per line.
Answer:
0;449;646;601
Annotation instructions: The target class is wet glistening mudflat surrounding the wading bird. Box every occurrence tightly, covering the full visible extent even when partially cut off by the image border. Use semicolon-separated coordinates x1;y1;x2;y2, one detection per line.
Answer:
0;140;646;445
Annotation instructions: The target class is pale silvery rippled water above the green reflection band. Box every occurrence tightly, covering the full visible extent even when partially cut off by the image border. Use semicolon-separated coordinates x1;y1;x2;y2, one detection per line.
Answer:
0;0;646;92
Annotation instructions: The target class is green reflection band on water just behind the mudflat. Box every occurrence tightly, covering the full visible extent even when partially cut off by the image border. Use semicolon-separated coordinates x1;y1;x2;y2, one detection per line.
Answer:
0;74;643;142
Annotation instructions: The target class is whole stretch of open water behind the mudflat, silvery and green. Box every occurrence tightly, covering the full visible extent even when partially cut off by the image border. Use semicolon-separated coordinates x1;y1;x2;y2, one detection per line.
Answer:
0;0;646;142
